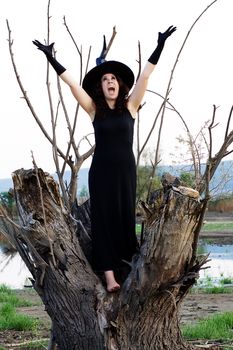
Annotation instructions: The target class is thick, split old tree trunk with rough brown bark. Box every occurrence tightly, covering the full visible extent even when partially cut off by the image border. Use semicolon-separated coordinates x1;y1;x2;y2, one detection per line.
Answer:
9;169;206;350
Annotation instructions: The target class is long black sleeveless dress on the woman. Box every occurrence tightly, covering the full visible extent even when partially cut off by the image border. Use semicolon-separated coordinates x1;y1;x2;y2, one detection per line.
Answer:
89;109;137;271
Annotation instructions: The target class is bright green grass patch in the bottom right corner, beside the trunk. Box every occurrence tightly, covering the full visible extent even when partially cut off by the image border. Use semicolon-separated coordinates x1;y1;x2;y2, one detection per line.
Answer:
182;312;233;340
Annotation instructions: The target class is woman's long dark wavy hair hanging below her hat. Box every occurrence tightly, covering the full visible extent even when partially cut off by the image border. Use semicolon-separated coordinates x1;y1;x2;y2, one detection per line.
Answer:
92;74;129;118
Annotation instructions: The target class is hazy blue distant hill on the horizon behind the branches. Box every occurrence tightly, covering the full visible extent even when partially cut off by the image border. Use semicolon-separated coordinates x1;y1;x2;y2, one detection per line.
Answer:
0;160;233;195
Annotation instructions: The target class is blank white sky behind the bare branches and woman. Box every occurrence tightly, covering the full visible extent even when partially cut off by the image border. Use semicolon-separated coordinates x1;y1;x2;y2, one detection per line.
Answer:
0;0;233;178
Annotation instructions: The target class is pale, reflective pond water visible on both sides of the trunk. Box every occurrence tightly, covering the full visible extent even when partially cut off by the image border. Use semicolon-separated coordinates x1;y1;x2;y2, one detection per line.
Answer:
0;240;233;289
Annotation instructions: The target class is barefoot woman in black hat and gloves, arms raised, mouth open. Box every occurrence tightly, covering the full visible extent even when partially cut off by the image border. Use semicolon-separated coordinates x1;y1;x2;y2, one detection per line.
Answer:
33;26;176;292
